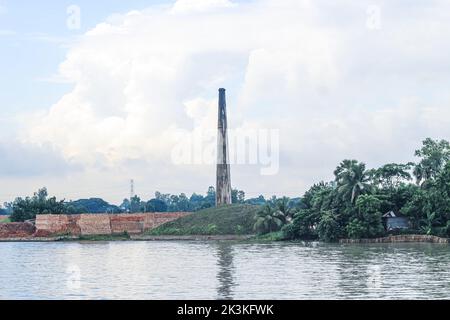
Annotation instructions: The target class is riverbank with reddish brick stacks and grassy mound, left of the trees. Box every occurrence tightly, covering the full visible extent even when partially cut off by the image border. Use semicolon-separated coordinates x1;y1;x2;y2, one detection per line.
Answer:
0;205;259;242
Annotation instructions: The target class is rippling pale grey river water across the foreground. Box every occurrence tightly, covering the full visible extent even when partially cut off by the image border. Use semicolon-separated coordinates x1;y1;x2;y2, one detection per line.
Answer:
0;241;450;299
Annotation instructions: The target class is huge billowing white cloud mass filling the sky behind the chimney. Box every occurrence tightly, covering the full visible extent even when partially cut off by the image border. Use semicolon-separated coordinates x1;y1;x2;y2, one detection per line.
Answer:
17;0;450;202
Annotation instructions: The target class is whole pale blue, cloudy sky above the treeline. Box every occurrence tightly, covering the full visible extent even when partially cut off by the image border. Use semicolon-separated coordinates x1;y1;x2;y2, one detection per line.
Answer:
0;0;450;203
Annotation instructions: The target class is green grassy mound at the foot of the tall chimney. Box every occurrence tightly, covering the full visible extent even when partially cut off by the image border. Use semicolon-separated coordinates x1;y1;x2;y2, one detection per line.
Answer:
146;205;260;236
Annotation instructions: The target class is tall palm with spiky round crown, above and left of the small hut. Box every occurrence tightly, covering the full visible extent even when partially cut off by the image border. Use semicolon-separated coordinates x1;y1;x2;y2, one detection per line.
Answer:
334;160;370;204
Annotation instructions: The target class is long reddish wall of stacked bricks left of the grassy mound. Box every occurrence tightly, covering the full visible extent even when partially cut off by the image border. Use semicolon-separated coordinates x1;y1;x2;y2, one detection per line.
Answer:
35;212;189;237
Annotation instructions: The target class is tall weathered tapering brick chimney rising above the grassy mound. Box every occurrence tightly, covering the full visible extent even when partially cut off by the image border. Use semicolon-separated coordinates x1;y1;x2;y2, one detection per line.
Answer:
216;88;231;206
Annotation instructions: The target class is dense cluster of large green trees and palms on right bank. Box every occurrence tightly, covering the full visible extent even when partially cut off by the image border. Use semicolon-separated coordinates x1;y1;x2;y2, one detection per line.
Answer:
255;138;450;242
